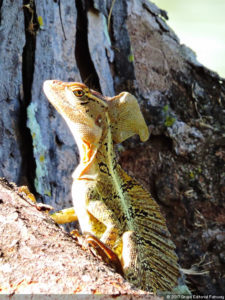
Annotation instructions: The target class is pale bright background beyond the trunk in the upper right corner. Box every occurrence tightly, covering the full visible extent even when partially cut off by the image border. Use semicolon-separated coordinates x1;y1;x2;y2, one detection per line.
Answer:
154;0;225;77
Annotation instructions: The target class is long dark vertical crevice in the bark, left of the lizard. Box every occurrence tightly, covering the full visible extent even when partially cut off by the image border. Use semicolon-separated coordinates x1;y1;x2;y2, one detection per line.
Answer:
19;0;39;192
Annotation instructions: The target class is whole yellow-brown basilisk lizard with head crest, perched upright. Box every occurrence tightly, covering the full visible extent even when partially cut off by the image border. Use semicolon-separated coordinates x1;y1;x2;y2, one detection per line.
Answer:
44;80;180;292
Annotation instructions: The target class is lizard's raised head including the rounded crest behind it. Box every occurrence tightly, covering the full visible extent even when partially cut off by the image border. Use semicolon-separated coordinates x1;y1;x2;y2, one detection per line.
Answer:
43;80;149;144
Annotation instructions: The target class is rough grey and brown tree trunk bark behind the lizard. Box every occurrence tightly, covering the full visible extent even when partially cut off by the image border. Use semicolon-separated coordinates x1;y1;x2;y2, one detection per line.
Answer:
0;0;225;294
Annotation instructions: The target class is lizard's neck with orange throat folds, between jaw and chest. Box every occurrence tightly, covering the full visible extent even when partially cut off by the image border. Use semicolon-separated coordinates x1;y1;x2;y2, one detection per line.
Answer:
73;113;117;180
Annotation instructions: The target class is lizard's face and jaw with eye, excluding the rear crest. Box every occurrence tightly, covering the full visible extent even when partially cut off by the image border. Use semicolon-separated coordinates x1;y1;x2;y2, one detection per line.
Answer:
43;80;108;144
